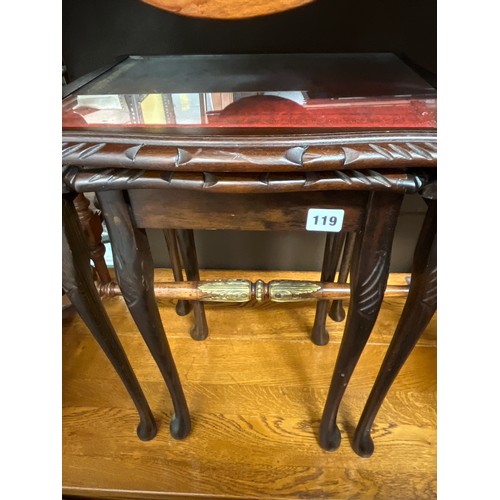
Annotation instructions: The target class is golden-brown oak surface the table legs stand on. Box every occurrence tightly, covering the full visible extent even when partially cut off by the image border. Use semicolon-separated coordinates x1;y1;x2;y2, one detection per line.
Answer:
62;270;436;500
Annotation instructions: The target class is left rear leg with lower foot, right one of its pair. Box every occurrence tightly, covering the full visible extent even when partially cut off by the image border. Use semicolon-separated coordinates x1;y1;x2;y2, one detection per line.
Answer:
176;229;208;340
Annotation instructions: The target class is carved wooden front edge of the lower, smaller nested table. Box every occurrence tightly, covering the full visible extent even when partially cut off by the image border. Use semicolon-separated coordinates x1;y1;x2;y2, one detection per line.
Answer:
63;167;425;193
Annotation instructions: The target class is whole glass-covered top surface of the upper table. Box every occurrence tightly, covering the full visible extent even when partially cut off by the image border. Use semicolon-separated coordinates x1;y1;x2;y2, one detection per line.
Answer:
62;53;437;134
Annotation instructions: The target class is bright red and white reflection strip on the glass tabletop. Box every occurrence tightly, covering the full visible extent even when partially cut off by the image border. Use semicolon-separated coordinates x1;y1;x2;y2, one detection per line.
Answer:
63;91;436;129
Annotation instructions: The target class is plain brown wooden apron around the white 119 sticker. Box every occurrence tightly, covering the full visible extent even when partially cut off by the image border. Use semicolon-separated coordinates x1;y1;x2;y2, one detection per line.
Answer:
129;189;369;231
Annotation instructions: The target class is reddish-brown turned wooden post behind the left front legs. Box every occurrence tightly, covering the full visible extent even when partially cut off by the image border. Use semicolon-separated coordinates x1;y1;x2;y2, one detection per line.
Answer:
73;193;111;283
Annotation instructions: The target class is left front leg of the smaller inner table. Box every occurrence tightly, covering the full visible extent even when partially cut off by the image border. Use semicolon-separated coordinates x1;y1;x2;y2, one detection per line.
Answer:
97;191;191;439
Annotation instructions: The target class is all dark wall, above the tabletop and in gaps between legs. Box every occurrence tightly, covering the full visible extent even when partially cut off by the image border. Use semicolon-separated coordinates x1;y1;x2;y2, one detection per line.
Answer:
62;0;436;272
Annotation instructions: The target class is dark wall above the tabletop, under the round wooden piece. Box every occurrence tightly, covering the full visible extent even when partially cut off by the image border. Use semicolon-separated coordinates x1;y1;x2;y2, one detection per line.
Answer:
62;0;436;78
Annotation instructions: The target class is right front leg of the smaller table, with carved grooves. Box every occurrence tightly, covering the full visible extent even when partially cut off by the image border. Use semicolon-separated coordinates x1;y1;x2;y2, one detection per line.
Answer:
319;192;403;451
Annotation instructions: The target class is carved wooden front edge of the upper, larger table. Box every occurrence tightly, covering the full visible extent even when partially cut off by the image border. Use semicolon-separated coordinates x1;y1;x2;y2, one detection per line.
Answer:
62;129;437;173
